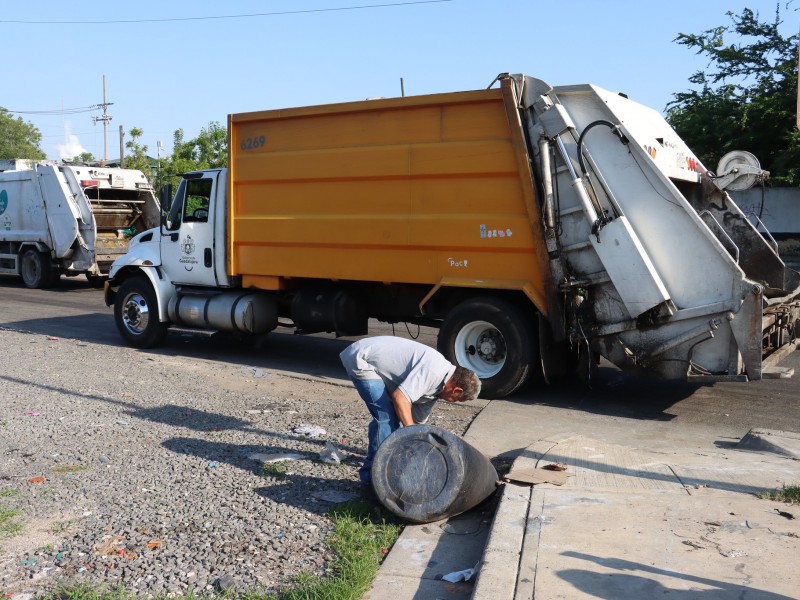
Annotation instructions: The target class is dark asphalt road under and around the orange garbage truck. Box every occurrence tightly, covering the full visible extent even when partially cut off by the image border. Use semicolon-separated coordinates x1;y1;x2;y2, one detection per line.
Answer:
0;275;800;436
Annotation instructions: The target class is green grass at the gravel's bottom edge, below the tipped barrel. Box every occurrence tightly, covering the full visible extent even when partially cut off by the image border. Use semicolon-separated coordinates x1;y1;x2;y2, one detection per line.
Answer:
34;500;401;600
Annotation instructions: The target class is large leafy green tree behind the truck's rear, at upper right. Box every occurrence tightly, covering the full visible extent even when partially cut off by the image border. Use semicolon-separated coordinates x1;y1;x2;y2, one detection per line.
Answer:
667;5;800;185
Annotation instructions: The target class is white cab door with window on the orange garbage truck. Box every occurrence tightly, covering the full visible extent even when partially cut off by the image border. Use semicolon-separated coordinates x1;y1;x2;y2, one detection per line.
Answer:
161;173;219;286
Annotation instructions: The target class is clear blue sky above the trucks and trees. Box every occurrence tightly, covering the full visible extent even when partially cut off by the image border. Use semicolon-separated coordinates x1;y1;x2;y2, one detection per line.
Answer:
0;0;800;158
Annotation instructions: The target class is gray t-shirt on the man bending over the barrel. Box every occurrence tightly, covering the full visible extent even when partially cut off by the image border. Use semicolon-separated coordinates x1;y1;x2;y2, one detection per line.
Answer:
339;336;456;404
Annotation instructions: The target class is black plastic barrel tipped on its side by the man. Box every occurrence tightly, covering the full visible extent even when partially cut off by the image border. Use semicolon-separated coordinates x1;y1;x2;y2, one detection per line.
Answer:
372;425;497;523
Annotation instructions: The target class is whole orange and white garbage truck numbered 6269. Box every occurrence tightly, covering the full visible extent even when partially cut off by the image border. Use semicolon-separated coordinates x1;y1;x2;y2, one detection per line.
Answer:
106;75;800;397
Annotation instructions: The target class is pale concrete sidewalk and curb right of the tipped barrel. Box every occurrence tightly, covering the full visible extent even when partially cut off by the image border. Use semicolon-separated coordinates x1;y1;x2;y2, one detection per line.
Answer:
365;403;800;600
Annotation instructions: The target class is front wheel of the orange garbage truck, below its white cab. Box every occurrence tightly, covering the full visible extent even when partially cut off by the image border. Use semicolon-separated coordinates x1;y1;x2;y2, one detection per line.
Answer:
114;276;167;348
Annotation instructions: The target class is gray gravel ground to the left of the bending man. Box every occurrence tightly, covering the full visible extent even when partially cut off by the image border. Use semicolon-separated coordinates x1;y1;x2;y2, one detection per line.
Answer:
0;330;479;598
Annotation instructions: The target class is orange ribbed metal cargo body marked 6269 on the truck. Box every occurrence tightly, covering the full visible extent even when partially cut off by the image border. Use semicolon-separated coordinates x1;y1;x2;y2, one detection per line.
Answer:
228;83;553;315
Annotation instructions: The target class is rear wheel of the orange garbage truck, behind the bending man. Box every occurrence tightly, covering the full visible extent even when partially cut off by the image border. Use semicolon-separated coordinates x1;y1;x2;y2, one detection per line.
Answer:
437;298;538;398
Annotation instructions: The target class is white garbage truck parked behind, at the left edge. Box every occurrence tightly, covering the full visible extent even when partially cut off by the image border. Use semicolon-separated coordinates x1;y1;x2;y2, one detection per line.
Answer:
0;159;160;288
